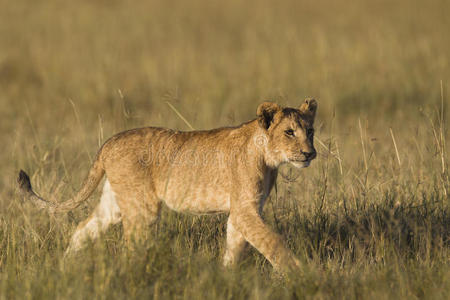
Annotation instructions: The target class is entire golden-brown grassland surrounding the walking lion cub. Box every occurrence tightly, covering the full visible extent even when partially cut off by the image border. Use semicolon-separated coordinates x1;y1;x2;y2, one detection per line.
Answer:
0;0;450;299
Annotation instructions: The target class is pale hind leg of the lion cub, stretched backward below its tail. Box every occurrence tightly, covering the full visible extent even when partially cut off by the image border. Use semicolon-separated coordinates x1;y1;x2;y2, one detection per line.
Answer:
64;179;121;256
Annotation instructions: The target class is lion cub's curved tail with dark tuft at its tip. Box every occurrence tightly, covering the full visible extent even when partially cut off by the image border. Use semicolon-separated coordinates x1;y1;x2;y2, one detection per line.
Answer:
17;156;105;213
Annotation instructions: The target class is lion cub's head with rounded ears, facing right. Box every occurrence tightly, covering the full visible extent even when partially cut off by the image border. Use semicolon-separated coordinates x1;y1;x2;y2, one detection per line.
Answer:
257;99;317;168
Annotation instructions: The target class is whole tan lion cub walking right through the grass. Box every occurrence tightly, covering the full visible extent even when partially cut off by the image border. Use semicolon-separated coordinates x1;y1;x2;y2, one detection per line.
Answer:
19;99;317;269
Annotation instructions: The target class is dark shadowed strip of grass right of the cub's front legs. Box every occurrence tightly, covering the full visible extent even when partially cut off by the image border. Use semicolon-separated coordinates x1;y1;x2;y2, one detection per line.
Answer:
272;199;450;262
